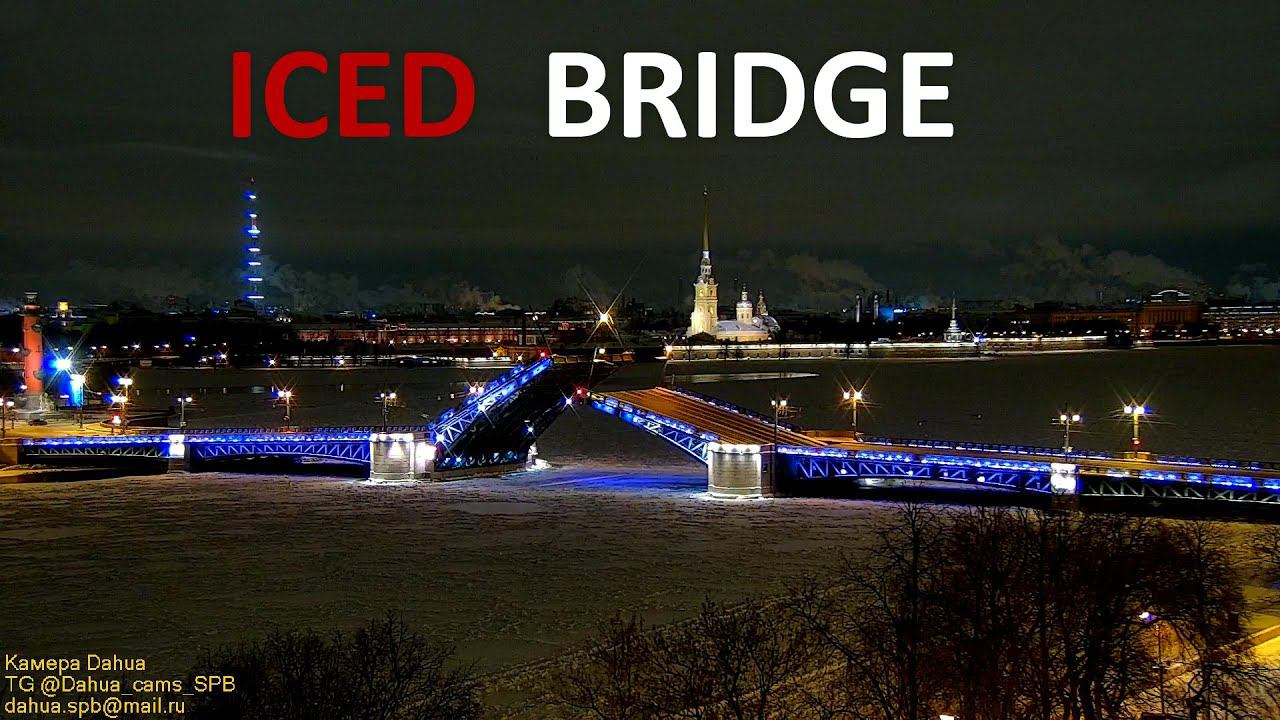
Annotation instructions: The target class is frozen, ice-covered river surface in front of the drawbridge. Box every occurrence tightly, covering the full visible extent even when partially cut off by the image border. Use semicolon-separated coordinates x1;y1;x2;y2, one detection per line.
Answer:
0;464;890;673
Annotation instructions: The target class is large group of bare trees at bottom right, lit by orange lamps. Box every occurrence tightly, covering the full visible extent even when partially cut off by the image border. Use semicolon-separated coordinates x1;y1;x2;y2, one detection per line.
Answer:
550;506;1280;720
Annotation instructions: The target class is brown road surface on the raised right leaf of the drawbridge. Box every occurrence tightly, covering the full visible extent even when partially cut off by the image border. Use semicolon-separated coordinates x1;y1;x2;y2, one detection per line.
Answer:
603;387;824;447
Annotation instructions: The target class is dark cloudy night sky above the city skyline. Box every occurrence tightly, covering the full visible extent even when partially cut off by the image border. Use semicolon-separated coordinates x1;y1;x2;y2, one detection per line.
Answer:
0;1;1280;310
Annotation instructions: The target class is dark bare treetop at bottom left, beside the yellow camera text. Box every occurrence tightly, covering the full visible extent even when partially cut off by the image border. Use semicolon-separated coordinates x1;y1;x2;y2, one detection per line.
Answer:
187;615;481;720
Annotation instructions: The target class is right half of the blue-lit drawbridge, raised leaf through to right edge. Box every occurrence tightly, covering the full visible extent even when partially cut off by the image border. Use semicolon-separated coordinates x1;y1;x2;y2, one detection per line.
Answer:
590;387;1280;505
